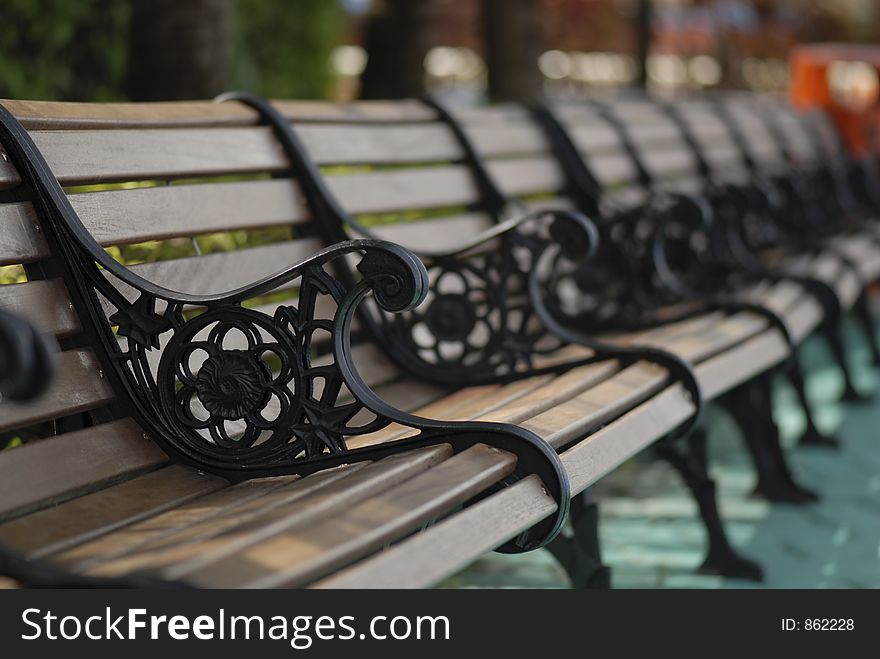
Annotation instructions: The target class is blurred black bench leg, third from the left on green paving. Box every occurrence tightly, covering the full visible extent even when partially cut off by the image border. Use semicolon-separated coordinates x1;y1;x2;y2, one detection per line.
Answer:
722;374;819;504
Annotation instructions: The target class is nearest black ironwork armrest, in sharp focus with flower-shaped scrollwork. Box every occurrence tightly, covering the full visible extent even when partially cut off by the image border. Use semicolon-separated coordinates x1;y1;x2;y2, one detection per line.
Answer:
0;107;570;551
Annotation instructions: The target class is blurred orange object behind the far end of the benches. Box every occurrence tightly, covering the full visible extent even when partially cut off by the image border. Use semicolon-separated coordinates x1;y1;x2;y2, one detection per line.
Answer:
791;43;880;156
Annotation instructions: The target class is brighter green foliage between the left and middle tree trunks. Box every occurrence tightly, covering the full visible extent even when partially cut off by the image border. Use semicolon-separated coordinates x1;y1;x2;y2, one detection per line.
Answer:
231;0;344;98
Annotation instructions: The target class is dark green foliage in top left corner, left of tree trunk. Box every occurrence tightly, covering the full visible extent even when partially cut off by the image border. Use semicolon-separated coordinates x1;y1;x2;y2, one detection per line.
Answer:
0;0;128;101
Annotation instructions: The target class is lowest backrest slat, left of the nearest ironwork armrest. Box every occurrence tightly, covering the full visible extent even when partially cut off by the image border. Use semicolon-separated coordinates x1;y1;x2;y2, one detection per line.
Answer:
0;419;167;519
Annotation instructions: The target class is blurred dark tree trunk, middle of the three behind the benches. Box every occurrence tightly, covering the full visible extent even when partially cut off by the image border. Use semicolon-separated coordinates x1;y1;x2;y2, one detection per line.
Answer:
361;0;437;98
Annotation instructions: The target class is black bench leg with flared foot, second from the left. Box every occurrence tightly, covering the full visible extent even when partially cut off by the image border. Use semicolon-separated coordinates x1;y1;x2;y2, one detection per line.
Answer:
657;428;764;581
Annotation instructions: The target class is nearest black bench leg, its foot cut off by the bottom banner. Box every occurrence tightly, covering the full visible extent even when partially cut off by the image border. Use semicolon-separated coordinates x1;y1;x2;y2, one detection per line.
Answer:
547;492;611;589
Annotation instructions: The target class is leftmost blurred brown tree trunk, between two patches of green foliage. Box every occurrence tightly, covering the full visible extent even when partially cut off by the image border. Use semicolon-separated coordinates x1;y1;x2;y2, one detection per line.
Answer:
126;0;232;101
